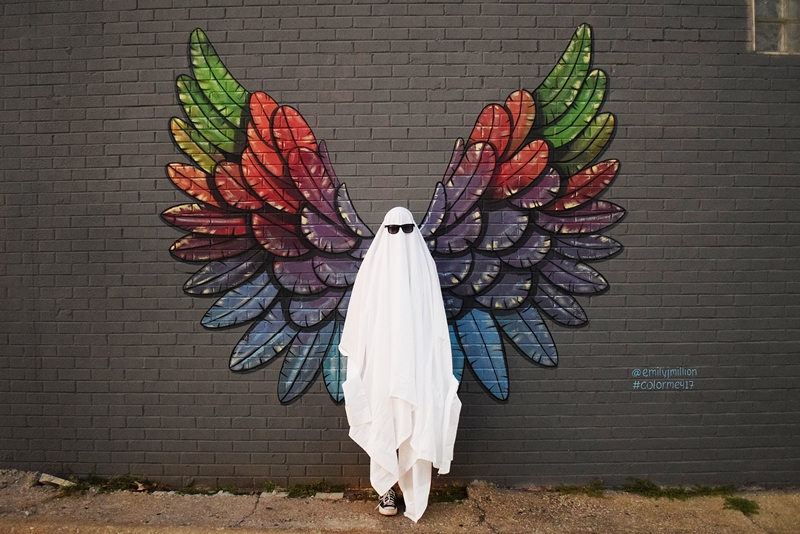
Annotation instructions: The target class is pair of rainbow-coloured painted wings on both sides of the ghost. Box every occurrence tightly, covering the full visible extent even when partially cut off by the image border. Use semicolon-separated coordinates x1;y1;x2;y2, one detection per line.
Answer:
162;25;625;403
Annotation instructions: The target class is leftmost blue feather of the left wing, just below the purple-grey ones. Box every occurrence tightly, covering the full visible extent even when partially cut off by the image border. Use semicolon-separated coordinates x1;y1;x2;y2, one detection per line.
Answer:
200;272;279;328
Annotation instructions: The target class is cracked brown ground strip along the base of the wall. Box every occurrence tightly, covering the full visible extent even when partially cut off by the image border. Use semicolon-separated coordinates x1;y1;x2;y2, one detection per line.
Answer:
0;470;800;534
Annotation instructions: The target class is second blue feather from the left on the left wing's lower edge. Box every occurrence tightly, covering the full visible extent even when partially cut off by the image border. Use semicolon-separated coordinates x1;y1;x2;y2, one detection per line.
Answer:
229;305;298;371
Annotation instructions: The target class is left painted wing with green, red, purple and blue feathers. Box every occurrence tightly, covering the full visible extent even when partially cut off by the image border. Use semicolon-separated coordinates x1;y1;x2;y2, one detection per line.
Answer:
162;29;372;402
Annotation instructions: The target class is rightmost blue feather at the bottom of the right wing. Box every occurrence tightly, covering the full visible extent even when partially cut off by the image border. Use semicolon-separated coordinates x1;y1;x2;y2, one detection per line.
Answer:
494;305;558;367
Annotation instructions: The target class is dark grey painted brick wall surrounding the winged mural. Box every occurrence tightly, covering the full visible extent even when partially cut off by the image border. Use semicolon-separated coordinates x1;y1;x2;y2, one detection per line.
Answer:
0;0;800;492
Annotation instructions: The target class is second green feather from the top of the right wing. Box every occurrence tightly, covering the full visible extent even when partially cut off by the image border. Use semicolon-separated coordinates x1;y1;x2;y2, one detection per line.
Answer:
541;70;607;148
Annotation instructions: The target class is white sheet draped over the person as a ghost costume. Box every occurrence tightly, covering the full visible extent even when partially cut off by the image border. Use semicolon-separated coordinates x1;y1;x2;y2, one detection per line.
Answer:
339;207;461;522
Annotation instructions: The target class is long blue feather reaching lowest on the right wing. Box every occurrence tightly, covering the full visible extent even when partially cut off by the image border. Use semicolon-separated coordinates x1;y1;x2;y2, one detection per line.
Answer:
456;309;508;400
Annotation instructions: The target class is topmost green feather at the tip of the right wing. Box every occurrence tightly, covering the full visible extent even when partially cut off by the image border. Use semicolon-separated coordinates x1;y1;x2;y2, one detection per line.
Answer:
534;24;592;124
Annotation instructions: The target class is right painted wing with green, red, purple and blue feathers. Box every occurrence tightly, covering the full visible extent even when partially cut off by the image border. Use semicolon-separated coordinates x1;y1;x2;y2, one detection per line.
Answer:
421;24;625;400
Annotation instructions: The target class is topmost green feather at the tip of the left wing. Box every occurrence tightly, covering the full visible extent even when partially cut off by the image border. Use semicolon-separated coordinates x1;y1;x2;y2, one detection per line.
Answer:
189;28;250;128
